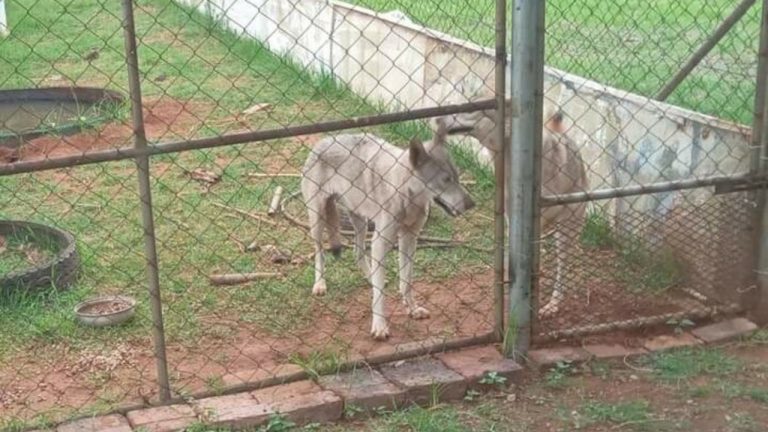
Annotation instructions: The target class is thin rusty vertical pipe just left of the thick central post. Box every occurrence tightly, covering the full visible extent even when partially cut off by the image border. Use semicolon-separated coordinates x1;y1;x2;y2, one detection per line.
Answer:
493;0;507;341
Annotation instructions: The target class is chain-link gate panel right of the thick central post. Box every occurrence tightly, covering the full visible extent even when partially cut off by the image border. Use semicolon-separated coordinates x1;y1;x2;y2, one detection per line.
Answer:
512;1;766;345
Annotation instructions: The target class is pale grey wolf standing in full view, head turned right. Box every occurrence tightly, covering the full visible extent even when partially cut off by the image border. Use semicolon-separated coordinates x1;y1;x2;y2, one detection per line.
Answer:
301;120;475;340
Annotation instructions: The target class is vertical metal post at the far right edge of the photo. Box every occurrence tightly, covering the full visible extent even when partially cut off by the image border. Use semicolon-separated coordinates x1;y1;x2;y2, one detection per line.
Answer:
750;0;768;324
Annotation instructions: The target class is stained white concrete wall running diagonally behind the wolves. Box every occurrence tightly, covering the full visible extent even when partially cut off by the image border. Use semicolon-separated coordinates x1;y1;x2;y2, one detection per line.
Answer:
177;0;750;219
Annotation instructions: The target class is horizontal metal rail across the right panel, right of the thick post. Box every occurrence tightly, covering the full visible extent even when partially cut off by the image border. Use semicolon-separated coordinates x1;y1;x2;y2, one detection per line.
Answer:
541;173;768;207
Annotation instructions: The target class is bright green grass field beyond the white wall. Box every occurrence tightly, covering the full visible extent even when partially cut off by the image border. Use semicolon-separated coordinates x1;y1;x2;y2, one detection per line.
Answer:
350;0;760;124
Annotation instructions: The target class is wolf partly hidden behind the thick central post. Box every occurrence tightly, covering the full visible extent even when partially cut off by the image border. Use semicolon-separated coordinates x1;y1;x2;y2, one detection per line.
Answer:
433;100;588;316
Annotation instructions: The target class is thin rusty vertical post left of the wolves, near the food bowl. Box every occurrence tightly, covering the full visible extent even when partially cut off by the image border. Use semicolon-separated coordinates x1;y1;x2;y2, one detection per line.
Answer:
123;0;171;402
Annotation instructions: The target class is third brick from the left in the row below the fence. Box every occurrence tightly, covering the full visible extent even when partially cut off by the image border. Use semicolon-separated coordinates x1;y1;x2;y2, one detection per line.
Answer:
195;393;270;428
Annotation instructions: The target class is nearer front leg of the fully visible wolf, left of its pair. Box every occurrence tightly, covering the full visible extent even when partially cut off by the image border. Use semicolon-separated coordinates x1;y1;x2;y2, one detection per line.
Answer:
371;223;395;340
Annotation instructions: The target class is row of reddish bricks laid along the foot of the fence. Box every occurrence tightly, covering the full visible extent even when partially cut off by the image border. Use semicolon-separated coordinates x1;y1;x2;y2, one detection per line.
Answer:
40;318;758;432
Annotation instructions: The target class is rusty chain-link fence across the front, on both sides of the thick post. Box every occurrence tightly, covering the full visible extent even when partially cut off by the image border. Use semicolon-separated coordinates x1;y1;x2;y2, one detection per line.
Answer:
0;0;760;428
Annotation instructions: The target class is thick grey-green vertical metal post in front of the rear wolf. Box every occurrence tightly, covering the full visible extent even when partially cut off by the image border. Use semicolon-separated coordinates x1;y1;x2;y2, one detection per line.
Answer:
504;0;545;358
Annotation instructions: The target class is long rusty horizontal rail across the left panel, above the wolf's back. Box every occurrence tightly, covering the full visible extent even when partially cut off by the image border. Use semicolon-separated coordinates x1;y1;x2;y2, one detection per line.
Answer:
0;99;496;177
